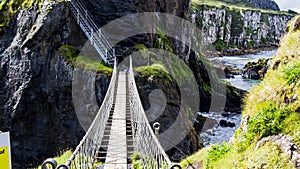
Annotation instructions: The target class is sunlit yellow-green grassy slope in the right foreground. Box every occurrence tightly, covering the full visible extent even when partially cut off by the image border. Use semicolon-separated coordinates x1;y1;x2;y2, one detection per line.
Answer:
181;16;300;169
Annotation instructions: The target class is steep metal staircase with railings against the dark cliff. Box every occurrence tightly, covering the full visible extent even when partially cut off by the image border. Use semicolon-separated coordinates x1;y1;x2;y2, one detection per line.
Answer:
67;0;115;64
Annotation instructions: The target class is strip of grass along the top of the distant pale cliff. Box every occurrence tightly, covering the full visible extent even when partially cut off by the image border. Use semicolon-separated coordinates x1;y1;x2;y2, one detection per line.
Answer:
192;0;294;16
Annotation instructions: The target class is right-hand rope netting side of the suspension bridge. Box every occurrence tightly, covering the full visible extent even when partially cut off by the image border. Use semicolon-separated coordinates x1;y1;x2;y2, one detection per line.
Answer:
128;56;180;169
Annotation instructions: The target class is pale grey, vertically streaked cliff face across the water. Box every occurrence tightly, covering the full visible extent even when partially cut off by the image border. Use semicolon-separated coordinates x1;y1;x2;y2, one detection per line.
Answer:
191;4;292;50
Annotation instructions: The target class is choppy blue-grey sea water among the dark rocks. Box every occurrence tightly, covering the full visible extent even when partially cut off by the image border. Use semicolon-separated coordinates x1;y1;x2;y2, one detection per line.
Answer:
199;50;276;146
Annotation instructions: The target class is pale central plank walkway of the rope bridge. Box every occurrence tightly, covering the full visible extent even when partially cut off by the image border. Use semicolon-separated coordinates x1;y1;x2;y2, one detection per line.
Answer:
104;72;127;169
